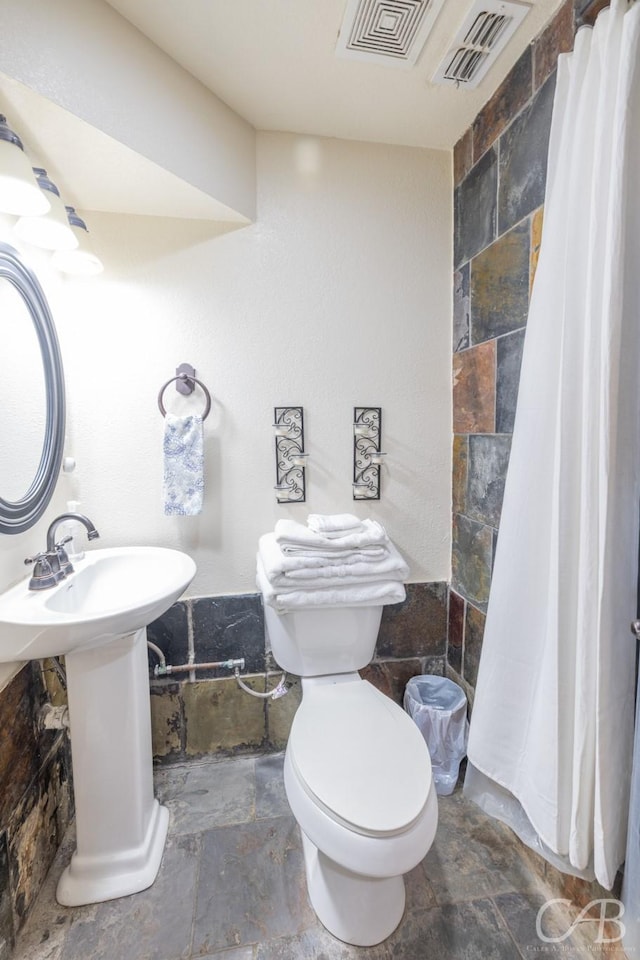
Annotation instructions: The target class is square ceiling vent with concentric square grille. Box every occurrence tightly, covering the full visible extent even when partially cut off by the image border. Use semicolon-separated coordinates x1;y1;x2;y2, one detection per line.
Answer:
336;0;444;67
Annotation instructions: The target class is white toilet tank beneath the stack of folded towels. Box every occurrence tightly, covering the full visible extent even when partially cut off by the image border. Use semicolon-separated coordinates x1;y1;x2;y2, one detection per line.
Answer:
264;603;382;677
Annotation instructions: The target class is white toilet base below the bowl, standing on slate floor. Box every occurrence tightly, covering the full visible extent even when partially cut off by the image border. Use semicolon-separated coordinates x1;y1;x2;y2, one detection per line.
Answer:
300;830;405;947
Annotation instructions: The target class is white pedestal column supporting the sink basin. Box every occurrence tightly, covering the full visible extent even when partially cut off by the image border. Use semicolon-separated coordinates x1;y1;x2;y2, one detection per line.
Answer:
56;628;169;907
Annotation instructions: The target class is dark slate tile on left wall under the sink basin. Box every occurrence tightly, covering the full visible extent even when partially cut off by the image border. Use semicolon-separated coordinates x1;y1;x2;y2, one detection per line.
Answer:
0;663;73;960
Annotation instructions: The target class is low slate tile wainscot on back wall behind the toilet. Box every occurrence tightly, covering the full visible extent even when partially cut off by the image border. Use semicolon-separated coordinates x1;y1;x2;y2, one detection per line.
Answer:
148;583;447;763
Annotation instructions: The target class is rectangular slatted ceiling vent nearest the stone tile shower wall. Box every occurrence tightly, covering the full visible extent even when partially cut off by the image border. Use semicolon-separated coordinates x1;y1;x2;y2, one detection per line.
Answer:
433;0;530;87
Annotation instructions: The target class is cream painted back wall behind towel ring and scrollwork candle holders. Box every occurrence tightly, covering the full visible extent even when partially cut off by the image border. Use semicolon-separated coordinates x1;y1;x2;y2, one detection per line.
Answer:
0;134;452;684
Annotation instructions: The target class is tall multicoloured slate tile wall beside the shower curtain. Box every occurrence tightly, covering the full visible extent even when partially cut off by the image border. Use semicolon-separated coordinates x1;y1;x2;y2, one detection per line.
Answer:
447;0;576;698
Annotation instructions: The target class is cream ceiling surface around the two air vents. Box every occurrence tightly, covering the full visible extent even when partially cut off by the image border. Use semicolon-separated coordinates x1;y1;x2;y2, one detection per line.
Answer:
109;0;562;149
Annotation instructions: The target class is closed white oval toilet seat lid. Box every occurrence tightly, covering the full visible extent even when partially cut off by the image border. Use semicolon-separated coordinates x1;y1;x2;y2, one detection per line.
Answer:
288;680;432;835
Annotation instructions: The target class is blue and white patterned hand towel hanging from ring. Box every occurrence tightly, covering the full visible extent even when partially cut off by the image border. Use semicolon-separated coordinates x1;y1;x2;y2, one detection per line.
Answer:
163;413;204;517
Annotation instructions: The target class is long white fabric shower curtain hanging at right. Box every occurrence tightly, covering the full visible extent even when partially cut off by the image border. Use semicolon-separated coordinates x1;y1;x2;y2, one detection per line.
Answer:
465;0;640;888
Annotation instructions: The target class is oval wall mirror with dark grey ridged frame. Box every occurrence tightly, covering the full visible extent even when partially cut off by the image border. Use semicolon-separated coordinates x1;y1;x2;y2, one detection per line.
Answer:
0;243;65;533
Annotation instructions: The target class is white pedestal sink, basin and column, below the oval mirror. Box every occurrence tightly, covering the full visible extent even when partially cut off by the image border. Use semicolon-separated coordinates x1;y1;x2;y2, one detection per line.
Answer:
0;547;196;906
